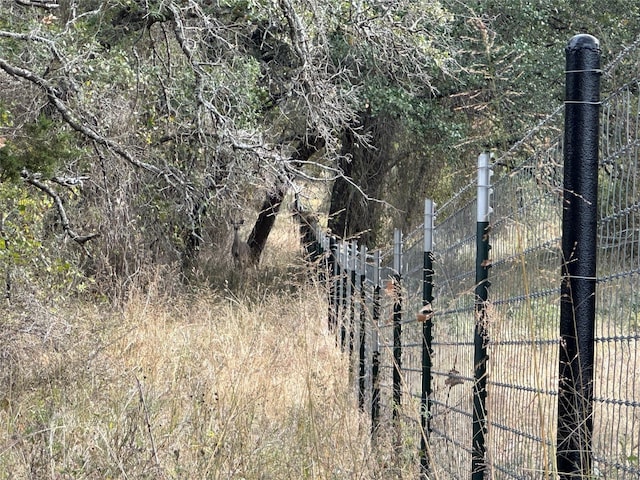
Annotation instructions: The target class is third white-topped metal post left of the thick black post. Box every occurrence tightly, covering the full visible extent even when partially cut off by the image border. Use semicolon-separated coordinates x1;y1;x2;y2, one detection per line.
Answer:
392;228;402;425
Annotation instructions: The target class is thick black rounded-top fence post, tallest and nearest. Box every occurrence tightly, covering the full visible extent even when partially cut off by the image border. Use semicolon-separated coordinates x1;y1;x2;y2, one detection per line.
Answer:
557;35;601;479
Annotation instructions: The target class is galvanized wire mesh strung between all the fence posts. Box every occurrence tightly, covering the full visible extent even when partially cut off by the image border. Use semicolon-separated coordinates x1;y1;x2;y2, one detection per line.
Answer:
316;33;640;479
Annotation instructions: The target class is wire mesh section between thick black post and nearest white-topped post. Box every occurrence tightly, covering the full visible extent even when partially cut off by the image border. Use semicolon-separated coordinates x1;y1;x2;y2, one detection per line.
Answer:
486;136;562;478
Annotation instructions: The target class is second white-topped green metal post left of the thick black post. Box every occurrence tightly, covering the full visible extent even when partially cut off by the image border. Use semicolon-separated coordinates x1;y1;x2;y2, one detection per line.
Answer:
419;199;435;479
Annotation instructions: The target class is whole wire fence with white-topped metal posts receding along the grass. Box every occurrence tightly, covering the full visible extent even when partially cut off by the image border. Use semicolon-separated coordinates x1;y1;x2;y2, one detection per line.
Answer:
317;32;640;480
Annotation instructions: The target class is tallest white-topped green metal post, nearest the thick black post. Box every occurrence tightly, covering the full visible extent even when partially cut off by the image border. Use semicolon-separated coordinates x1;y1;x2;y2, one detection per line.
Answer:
471;153;493;480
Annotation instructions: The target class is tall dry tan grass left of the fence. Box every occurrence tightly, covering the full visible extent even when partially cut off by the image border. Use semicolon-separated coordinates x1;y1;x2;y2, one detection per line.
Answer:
0;217;390;480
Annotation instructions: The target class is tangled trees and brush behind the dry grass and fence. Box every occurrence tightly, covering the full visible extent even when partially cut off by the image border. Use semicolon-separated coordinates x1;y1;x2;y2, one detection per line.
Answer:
0;0;640;302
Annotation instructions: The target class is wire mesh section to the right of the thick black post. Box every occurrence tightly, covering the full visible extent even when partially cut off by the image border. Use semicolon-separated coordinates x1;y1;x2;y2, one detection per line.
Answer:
593;68;640;479
